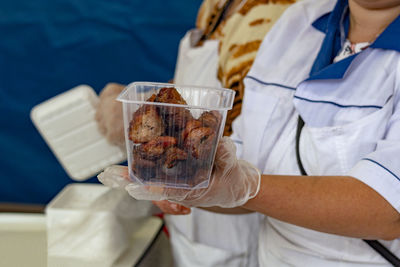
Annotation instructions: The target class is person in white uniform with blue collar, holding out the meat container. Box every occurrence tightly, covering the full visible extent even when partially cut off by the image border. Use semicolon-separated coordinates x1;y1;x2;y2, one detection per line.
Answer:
99;0;400;267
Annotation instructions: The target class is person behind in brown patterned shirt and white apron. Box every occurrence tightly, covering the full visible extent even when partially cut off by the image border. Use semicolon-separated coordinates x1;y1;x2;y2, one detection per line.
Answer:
97;0;295;266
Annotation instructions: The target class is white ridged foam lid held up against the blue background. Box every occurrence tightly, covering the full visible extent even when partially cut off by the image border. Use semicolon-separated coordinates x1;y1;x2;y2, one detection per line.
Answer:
31;85;126;181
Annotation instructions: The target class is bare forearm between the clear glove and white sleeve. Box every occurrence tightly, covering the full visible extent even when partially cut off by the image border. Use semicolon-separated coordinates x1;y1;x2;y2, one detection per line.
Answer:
244;175;400;239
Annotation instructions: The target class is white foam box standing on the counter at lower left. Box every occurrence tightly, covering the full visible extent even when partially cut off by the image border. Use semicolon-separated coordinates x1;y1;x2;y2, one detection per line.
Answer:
46;184;151;267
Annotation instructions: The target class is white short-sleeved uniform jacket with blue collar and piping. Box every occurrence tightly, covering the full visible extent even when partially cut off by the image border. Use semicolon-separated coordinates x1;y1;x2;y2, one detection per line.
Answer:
232;0;400;267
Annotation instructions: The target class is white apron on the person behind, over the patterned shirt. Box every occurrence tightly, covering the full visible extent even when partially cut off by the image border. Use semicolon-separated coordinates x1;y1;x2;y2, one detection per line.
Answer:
165;30;260;267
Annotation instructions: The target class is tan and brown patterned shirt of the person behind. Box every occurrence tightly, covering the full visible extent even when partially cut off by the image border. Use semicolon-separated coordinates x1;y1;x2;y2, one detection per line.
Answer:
196;0;296;135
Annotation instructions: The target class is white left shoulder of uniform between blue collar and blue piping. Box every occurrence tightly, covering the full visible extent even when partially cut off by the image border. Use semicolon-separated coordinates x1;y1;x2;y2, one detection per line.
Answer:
247;0;336;87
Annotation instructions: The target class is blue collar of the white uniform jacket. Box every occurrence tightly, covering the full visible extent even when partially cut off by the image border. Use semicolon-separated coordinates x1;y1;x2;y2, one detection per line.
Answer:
307;0;400;80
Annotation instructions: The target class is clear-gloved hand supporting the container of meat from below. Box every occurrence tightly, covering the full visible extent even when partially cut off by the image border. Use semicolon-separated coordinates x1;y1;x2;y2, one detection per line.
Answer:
98;137;261;208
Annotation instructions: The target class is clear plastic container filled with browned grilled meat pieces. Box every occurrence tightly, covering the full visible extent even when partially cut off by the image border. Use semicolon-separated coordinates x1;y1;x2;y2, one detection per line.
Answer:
118;82;235;189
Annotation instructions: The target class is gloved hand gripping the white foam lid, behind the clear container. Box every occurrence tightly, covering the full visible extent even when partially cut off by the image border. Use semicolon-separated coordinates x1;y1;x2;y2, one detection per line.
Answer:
96;83;125;148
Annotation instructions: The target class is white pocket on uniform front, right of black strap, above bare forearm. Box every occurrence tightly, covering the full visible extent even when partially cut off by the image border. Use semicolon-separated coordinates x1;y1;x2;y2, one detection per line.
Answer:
300;99;393;175
